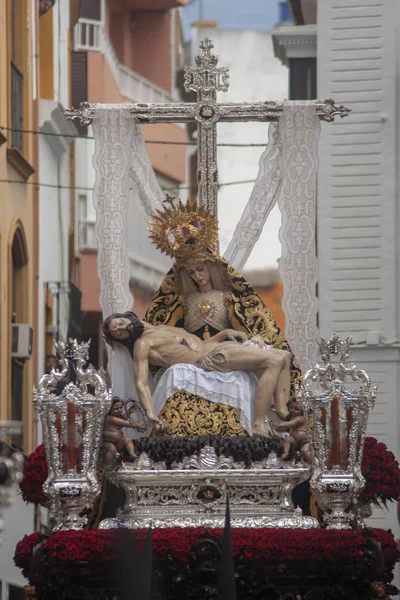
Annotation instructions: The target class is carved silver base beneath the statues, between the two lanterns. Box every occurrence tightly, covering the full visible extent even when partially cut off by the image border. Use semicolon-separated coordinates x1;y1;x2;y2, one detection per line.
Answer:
100;446;318;529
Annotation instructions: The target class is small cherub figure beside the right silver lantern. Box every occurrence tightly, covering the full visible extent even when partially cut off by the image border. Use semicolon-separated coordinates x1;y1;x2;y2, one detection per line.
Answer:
271;400;311;463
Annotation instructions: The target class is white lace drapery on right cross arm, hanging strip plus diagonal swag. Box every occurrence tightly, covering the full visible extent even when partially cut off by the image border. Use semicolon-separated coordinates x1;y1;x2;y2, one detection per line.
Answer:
224;102;321;372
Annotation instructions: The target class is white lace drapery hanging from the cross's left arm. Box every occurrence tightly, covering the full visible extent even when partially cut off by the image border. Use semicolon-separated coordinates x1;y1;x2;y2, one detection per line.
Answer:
93;105;163;399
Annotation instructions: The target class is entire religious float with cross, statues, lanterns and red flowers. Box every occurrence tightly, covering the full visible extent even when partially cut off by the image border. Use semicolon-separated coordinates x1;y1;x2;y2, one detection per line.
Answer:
9;40;400;600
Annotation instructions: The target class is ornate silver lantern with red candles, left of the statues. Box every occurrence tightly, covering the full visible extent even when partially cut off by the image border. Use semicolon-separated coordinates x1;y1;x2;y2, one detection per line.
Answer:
34;340;111;529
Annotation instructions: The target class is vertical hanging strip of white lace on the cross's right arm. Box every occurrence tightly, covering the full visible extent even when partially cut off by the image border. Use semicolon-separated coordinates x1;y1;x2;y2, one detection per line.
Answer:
279;102;321;373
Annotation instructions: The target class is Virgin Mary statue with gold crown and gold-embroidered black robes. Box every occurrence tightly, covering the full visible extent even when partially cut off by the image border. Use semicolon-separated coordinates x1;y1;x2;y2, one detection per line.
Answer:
145;198;301;435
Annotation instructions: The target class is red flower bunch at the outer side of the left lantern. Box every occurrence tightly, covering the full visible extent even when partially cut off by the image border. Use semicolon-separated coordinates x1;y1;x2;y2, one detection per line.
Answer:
19;444;48;504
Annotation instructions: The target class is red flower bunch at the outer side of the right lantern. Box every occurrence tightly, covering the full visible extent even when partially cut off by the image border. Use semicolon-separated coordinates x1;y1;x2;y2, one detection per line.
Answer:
360;437;400;506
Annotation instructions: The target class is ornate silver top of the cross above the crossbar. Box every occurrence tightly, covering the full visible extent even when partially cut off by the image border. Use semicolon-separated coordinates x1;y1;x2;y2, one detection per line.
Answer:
185;38;229;99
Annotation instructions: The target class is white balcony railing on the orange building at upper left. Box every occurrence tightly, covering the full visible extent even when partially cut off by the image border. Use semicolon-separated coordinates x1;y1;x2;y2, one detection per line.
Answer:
74;19;174;103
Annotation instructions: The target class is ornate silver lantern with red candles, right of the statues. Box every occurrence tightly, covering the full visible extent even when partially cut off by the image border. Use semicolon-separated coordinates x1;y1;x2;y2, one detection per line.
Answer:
298;333;377;529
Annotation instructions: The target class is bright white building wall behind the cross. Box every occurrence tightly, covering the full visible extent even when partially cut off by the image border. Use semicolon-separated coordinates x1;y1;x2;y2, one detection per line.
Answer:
192;27;288;269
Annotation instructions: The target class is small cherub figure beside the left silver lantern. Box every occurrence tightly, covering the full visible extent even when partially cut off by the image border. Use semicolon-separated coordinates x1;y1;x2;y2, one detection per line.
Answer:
102;396;146;466
